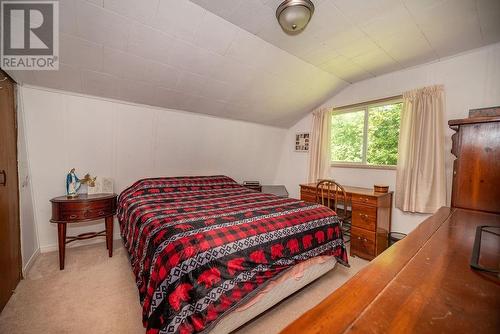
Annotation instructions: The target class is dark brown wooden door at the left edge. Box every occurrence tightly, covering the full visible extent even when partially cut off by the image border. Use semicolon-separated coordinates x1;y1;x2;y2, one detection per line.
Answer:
0;71;21;311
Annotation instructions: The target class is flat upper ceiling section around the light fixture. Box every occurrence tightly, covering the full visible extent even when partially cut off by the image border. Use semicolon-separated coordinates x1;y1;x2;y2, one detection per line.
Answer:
191;0;500;82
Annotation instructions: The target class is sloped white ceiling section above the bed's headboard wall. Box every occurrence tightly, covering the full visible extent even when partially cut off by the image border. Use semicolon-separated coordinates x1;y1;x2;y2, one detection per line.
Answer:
4;0;346;127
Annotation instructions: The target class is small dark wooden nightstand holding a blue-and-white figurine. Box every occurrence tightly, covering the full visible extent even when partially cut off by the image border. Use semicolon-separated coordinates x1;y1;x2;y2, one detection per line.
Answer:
50;194;117;270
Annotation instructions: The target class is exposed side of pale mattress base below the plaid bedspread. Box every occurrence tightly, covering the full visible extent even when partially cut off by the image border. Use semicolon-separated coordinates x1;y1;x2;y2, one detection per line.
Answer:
210;256;337;334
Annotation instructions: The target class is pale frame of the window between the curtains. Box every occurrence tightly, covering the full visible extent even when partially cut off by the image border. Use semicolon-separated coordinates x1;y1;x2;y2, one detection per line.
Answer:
330;97;403;170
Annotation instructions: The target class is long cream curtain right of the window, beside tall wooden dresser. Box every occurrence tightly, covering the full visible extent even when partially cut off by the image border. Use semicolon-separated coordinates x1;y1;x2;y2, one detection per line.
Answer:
396;85;446;213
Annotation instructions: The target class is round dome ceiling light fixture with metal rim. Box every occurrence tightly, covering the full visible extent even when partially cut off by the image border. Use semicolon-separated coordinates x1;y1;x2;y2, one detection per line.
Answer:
276;0;314;35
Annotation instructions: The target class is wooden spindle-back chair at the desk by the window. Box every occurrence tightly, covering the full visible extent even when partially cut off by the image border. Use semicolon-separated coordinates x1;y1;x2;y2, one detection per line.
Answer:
316;180;352;242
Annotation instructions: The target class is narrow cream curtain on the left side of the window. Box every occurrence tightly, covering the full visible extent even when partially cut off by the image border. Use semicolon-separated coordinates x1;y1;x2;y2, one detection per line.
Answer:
308;108;332;182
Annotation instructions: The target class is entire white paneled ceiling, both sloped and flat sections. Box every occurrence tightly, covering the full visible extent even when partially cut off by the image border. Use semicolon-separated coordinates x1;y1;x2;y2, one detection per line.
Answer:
9;0;500;127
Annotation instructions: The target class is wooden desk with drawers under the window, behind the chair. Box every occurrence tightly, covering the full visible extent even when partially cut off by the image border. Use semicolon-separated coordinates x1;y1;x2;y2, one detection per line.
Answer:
300;183;393;260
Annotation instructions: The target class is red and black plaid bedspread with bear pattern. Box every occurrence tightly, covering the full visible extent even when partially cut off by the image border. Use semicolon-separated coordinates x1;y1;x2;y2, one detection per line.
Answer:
118;176;347;334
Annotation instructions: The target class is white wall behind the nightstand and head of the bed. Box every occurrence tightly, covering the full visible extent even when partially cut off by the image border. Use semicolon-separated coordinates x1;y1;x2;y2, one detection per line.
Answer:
22;87;286;251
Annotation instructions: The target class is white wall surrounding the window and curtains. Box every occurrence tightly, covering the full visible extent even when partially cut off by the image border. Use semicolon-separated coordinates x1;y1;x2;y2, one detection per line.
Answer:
276;44;500;232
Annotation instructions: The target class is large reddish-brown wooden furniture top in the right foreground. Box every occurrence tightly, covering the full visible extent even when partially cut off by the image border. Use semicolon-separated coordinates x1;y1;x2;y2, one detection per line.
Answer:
282;207;500;334
